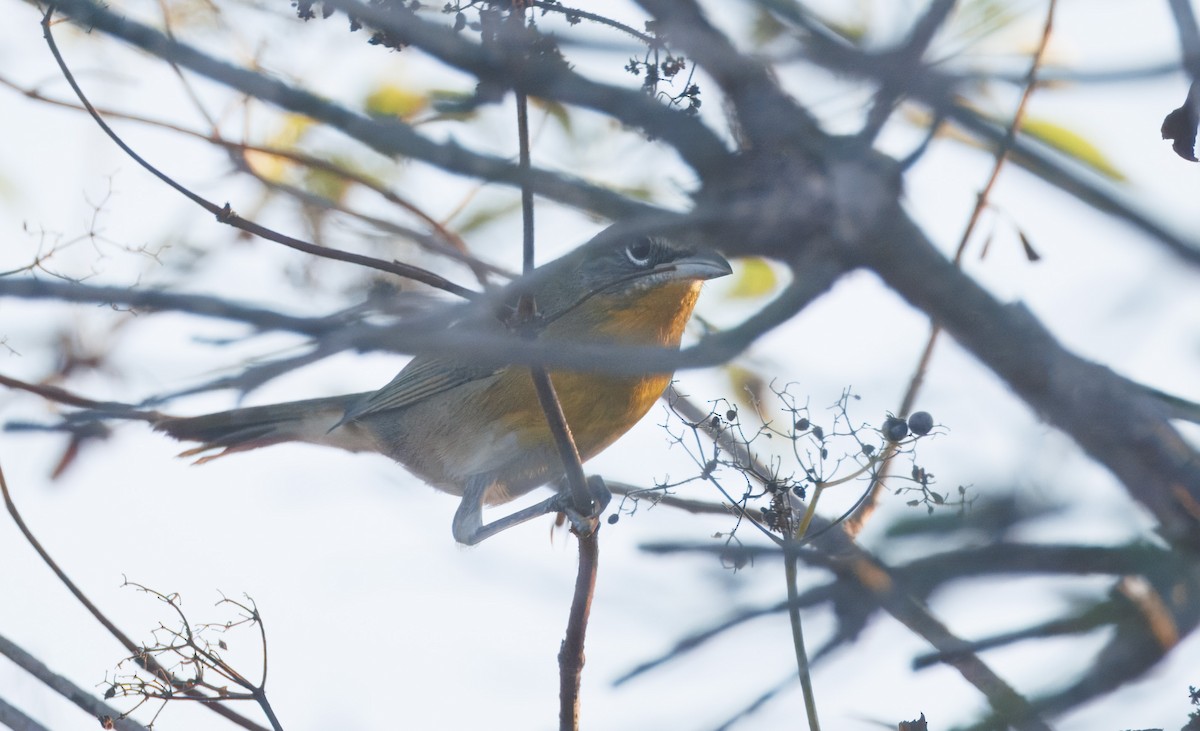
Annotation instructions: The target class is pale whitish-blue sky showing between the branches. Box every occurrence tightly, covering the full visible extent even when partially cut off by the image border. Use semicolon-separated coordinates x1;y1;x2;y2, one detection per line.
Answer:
0;0;1200;731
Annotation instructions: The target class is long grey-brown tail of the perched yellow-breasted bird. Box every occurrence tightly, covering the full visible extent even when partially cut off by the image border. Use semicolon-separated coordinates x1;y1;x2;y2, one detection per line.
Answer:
151;394;374;465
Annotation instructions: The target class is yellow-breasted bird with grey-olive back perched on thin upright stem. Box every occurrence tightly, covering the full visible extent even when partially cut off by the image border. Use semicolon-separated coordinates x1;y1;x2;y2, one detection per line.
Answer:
154;234;731;544
